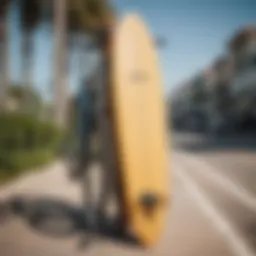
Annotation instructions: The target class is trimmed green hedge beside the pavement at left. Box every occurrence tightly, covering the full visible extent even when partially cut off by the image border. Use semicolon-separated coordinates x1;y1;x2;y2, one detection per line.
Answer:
0;113;64;183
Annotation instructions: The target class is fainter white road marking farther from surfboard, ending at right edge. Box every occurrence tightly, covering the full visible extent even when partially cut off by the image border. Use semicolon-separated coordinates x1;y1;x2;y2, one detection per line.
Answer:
175;153;256;212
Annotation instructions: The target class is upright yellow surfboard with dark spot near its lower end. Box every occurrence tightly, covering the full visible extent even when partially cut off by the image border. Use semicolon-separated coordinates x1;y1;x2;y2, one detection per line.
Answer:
110;14;169;246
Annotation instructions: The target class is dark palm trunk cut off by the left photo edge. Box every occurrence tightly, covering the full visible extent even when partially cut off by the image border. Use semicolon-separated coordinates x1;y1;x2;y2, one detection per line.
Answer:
0;0;10;107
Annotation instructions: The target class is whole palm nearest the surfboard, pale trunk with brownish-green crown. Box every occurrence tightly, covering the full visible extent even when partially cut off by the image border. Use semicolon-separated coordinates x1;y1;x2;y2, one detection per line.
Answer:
54;0;115;127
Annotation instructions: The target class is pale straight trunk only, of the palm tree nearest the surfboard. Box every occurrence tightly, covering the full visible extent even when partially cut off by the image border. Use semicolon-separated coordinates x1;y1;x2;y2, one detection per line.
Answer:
54;0;68;126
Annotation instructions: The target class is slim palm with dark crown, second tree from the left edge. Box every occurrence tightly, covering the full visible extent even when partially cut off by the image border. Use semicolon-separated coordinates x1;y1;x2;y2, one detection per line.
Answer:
20;0;40;108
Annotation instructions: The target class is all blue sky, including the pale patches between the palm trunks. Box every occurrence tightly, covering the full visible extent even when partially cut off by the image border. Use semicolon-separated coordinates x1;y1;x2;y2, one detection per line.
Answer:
10;0;256;98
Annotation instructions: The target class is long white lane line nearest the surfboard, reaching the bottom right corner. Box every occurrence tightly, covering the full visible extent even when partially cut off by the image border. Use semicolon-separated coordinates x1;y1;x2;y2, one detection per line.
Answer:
175;166;255;256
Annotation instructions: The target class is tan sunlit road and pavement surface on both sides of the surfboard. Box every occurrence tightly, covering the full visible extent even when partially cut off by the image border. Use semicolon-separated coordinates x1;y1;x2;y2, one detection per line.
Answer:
0;134;256;256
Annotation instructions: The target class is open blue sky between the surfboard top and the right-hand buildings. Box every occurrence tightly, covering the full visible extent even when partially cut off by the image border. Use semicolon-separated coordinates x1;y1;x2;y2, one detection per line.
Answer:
112;0;256;92
